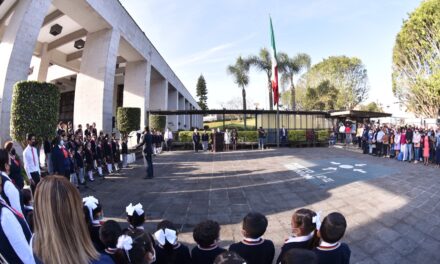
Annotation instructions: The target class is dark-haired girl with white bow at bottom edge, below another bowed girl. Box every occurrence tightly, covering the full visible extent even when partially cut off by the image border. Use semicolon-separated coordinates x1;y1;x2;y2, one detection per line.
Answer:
116;230;157;264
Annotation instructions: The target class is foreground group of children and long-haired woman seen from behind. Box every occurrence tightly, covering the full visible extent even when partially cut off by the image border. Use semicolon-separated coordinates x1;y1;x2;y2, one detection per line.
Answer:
0;169;351;264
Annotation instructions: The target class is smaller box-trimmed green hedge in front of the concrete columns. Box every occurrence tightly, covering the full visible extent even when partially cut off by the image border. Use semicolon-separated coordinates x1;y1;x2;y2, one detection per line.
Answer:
116;107;141;135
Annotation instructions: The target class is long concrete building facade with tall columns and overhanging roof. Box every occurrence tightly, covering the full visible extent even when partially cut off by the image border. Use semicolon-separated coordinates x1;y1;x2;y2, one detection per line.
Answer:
0;0;203;142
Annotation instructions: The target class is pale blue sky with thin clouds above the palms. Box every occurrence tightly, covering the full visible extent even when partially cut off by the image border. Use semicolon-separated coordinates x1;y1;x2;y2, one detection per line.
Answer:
120;0;421;111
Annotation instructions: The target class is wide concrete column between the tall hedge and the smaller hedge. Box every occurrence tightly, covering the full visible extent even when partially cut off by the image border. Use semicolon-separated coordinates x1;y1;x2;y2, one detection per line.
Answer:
73;29;120;133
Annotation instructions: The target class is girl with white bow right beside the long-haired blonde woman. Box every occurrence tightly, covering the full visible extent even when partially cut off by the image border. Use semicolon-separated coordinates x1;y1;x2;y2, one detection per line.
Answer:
83;196;105;251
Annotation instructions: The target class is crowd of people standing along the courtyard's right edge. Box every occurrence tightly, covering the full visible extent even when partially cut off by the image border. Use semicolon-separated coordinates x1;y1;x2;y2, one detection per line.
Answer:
330;124;440;167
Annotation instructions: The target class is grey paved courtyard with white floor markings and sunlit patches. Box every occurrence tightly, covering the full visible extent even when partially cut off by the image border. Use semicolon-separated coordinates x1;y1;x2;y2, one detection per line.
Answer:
82;148;440;264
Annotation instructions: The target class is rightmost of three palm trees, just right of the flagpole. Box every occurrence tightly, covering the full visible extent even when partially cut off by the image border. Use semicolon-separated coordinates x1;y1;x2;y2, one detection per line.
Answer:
278;53;312;110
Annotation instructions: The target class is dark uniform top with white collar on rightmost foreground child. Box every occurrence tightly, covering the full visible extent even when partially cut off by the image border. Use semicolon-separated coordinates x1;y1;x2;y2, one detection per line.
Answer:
313;242;351;264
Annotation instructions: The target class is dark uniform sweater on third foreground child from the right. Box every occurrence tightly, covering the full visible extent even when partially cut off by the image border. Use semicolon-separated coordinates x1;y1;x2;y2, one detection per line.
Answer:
229;237;275;264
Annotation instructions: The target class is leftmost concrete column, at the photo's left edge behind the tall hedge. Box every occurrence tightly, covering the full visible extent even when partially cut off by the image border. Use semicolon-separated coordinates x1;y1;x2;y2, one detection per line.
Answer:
0;0;51;143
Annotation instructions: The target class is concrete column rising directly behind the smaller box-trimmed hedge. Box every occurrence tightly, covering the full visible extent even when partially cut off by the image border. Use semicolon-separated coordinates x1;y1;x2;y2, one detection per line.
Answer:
123;61;151;129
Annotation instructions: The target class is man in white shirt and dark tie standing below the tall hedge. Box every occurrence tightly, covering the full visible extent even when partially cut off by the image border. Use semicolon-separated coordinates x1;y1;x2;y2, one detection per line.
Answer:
23;133;41;193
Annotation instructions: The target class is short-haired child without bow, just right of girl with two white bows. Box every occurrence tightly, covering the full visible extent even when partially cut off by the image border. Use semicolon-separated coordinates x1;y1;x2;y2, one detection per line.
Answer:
191;220;226;264
